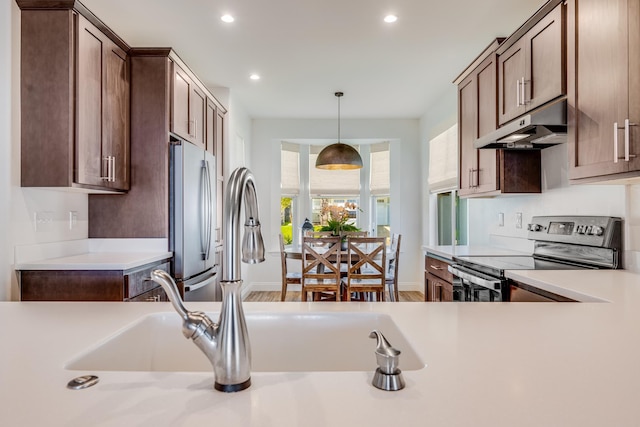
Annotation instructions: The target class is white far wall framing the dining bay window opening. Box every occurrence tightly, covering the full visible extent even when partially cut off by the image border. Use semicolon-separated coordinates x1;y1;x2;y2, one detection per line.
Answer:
248;119;423;289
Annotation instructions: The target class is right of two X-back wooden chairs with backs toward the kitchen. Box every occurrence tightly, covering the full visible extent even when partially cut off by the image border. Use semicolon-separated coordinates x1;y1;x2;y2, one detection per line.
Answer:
345;237;387;301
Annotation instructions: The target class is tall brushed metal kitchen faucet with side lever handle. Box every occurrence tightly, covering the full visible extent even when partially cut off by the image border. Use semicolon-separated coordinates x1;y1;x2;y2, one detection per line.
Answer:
151;168;264;392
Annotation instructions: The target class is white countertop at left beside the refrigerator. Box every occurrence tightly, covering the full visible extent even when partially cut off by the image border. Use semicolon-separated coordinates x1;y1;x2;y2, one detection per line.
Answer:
15;252;173;270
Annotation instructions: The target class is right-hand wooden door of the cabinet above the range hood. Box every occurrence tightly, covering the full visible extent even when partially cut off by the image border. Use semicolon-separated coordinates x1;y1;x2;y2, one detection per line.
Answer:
523;4;566;110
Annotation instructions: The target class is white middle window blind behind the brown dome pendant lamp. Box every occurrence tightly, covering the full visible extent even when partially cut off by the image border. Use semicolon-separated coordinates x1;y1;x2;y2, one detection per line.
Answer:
309;145;360;196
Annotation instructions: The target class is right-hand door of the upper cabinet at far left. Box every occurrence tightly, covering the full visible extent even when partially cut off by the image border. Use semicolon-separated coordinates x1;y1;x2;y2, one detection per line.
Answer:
102;41;130;190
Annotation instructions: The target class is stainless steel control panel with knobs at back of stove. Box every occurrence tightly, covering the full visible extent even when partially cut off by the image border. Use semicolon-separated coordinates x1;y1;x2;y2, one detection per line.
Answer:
527;216;622;247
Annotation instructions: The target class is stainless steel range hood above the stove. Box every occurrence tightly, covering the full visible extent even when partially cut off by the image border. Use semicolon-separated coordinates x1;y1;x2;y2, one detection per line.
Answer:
473;98;567;150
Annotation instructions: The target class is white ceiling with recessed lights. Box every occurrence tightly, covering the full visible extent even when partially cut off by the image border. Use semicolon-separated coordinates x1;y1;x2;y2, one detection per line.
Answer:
82;0;544;118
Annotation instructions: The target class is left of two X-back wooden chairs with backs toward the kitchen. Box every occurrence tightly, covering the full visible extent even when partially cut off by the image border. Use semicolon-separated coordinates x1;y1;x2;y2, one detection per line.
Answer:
302;236;342;301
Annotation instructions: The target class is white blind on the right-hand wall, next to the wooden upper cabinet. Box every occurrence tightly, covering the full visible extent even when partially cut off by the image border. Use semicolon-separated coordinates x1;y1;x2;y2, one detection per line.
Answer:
429;123;458;193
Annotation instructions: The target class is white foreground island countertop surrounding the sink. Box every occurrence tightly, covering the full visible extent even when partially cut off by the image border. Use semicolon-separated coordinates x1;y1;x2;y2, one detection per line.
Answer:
0;270;640;427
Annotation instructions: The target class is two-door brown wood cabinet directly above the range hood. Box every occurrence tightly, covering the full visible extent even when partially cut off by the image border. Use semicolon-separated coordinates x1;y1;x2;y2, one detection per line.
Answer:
498;1;566;125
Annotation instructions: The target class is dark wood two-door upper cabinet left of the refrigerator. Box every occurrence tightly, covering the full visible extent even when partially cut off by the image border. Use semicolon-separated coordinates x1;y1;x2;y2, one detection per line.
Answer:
18;2;130;192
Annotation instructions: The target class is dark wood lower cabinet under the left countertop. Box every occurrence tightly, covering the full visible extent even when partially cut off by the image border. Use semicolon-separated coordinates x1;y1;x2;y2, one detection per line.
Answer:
19;261;169;301
